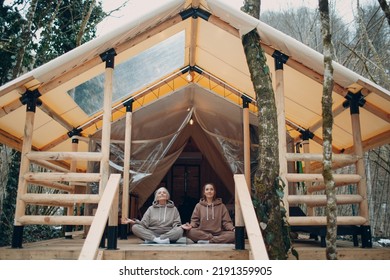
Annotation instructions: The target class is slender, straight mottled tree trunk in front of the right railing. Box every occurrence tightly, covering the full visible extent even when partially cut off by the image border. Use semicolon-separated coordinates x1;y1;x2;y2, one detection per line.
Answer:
319;0;337;260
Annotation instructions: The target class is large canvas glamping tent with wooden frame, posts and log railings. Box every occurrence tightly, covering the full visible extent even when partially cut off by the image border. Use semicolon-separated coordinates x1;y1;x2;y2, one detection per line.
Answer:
0;0;390;258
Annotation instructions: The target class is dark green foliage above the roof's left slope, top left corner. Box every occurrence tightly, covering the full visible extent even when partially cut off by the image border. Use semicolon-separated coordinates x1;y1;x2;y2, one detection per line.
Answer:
0;0;106;85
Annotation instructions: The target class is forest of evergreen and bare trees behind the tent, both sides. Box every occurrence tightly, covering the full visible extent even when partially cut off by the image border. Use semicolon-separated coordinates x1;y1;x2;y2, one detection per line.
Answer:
0;0;390;246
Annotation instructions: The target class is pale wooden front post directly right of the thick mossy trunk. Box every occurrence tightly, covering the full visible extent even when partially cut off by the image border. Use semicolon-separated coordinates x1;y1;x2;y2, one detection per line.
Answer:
272;51;289;216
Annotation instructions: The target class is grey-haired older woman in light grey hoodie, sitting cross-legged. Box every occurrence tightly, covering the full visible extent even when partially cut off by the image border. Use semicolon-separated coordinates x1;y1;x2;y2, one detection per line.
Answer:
122;187;183;244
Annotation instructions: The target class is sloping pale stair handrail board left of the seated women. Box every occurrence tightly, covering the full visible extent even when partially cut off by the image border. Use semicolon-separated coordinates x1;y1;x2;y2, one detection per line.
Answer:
79;174;121;260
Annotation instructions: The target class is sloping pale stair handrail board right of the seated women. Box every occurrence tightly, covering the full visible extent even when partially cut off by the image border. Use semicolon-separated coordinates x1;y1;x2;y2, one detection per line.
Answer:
234;174;269;260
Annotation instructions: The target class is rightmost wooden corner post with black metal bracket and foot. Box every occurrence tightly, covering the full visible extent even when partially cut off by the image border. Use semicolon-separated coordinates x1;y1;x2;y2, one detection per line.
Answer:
344;92;372;248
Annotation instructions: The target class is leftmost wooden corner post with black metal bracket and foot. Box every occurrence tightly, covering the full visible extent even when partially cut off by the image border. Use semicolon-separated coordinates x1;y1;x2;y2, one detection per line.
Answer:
12;90;40;248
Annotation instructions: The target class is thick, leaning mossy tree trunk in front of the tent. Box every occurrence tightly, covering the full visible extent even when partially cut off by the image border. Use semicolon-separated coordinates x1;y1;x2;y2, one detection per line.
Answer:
241;0;290;259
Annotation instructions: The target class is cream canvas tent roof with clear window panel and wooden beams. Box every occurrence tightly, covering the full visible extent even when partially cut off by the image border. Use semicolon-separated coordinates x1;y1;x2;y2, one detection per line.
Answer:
0;0;390;174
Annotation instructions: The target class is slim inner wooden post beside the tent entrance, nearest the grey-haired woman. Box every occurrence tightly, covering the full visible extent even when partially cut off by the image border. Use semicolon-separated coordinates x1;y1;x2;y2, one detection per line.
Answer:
121;99;135;239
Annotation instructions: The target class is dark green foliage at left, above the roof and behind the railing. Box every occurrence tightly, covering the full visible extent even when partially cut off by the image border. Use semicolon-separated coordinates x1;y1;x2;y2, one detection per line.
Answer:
0;0;106;246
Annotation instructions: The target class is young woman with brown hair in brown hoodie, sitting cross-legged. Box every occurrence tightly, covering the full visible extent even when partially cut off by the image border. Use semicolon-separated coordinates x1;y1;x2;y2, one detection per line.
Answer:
182;184;235;243
